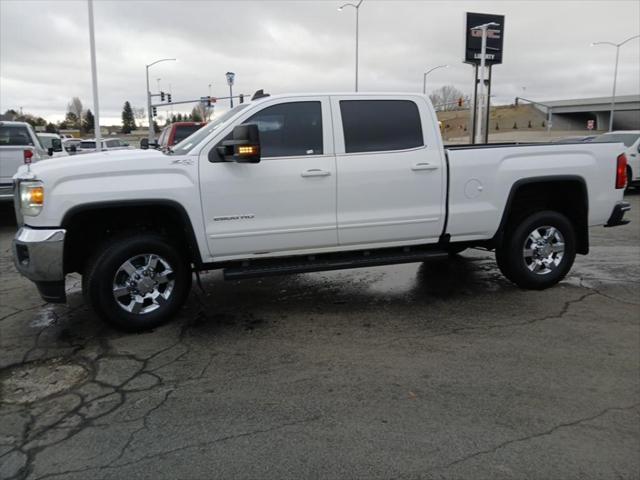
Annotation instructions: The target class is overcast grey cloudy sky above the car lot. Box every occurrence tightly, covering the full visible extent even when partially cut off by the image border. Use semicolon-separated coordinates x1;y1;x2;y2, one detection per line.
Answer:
0;0;640;125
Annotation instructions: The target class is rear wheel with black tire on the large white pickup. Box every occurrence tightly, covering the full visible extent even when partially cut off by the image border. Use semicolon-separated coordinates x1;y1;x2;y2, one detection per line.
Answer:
496;211;576;290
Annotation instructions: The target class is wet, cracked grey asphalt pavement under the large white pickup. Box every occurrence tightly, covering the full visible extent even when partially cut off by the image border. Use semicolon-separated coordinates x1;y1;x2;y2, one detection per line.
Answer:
0;194;640;480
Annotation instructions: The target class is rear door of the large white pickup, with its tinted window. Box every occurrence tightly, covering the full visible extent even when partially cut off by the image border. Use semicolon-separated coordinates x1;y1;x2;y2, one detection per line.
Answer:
331;94;446;245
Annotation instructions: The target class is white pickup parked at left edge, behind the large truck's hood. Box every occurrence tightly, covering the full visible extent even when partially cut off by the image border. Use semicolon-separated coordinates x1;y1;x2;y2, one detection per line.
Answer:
0;121;49;202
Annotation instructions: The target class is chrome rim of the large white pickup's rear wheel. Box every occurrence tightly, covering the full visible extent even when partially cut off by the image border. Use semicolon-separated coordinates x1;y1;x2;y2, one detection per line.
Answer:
522;225;564;275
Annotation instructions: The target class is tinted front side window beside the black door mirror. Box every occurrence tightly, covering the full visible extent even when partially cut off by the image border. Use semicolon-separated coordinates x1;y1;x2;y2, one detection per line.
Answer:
244;101;323;158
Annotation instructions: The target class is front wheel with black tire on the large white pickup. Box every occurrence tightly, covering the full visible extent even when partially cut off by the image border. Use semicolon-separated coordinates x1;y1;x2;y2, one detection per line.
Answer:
82;233;192;331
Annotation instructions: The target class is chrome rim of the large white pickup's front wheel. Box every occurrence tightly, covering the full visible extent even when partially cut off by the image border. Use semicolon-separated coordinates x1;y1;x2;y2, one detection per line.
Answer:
113;253;175;315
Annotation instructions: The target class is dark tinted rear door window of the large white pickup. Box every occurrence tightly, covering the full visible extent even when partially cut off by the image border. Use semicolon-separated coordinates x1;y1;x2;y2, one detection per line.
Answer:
340;100;424;153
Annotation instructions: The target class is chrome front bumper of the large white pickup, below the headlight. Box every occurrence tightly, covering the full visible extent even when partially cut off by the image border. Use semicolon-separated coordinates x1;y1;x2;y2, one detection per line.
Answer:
13;227;66;303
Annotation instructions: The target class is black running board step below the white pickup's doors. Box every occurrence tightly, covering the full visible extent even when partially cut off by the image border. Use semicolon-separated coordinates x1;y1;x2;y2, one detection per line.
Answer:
224;248;448;280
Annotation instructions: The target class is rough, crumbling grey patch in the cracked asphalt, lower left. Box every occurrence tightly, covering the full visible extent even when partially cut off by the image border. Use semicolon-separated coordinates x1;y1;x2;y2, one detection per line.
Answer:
0;359;89;404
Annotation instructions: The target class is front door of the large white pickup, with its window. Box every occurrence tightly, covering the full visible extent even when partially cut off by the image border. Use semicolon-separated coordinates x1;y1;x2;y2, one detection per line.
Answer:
200;97;337;260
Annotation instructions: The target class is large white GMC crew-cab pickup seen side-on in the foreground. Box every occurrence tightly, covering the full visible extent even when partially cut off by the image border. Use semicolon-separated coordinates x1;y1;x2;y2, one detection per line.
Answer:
13;92;629;330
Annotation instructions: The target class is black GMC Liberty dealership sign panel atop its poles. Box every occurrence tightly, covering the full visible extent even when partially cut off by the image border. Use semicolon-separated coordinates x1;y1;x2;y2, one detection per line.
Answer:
464;12;504;66
